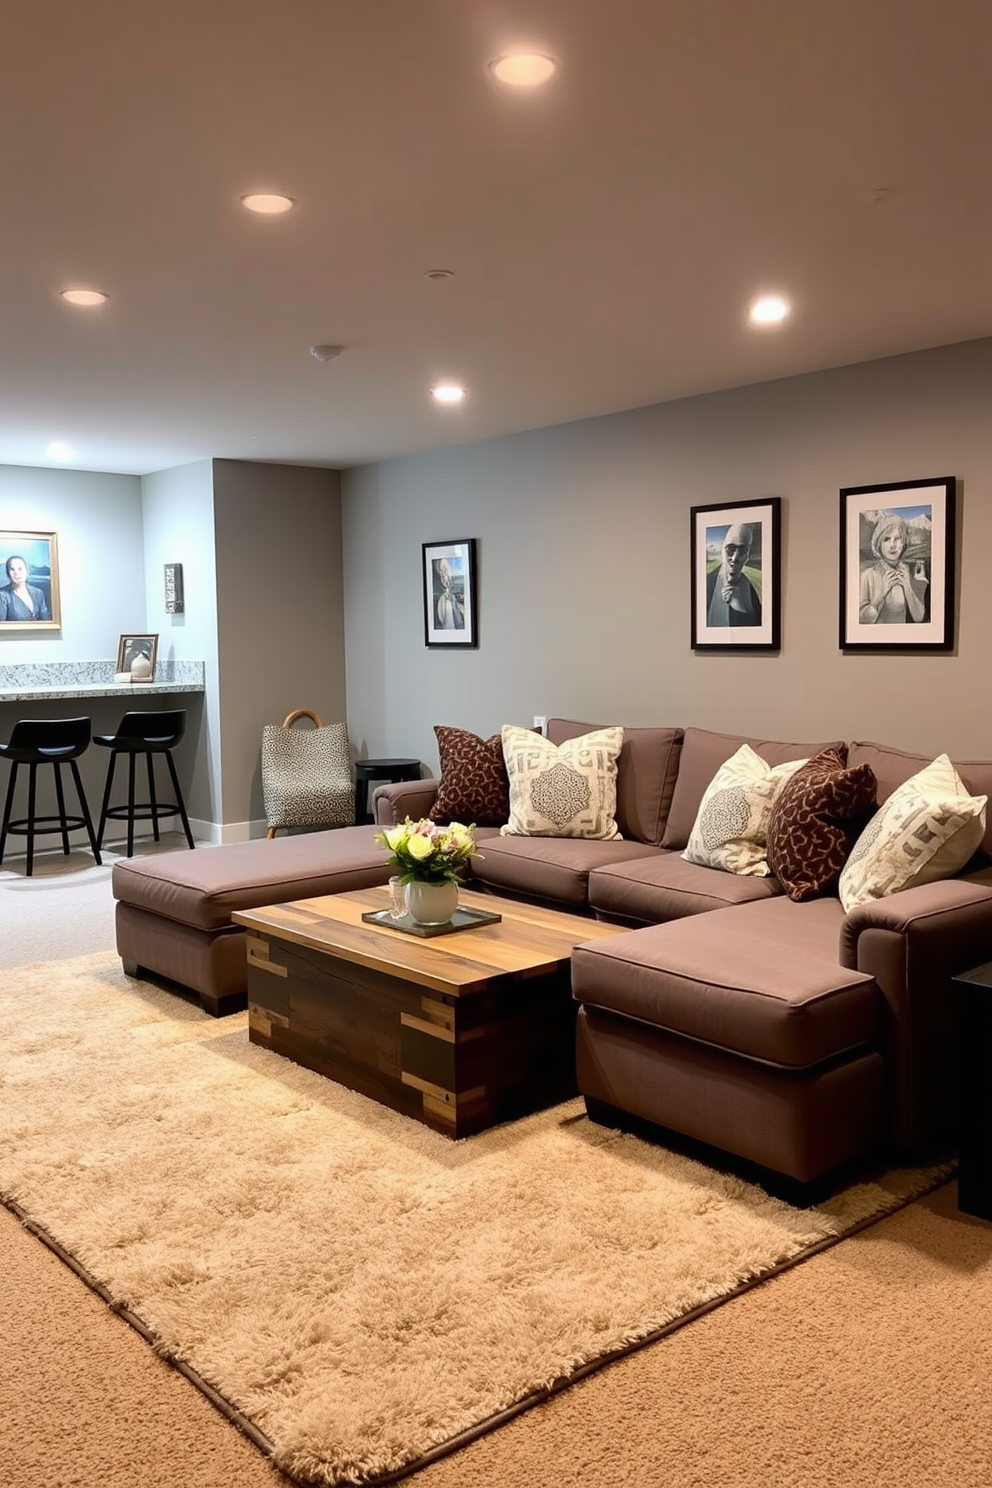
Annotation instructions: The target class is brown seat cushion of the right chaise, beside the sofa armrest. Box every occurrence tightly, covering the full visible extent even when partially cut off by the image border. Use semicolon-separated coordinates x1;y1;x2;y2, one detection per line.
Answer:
571;897;879;1070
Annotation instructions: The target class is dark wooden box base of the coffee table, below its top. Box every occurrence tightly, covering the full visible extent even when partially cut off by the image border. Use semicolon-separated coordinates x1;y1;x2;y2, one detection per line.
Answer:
248;931;577;1137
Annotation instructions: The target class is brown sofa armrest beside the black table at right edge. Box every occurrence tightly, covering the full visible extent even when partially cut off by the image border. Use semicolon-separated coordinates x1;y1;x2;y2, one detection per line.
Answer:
840;878;992;1149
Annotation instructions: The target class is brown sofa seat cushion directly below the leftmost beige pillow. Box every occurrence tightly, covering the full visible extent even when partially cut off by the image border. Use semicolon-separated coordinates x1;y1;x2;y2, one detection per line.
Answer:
471;836;662;906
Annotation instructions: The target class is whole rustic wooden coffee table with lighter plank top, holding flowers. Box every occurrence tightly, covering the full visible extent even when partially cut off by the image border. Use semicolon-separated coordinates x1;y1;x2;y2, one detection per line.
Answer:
233;888;622;1137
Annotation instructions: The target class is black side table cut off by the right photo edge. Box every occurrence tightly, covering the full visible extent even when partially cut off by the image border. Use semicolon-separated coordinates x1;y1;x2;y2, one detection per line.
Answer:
952;961;992;1219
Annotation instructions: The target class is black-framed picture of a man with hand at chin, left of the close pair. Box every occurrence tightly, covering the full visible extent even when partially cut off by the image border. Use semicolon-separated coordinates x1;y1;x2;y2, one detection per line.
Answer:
690;496;782;650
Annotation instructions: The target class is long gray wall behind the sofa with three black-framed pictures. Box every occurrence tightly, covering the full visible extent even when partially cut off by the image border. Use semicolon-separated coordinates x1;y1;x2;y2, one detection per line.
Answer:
344;339;992;771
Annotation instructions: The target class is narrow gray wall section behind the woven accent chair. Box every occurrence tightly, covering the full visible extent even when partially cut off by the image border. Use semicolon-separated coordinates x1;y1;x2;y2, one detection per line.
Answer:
213;460;345;839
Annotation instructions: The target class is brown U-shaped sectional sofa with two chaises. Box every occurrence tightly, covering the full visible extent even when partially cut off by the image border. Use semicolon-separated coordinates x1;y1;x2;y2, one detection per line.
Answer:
113;719;992;1184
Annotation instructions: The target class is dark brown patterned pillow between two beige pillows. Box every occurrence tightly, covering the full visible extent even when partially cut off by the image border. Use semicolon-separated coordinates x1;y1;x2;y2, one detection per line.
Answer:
767;748;876;900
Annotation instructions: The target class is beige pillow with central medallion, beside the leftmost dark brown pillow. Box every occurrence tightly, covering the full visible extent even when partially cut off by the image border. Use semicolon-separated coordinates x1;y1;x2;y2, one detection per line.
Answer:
500;723;623;841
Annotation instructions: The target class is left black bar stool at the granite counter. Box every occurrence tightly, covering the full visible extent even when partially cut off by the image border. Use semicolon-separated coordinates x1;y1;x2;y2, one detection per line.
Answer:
0;719;103;878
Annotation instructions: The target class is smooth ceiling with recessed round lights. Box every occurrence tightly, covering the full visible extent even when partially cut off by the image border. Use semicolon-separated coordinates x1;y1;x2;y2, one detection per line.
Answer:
0;0;992;473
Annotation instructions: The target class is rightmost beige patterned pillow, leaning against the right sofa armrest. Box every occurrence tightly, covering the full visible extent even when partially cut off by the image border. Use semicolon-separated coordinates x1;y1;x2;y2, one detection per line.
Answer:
837;754;989;914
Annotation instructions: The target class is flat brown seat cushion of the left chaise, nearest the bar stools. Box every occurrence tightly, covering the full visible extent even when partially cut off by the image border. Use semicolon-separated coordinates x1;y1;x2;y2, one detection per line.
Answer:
112;826;393;930
